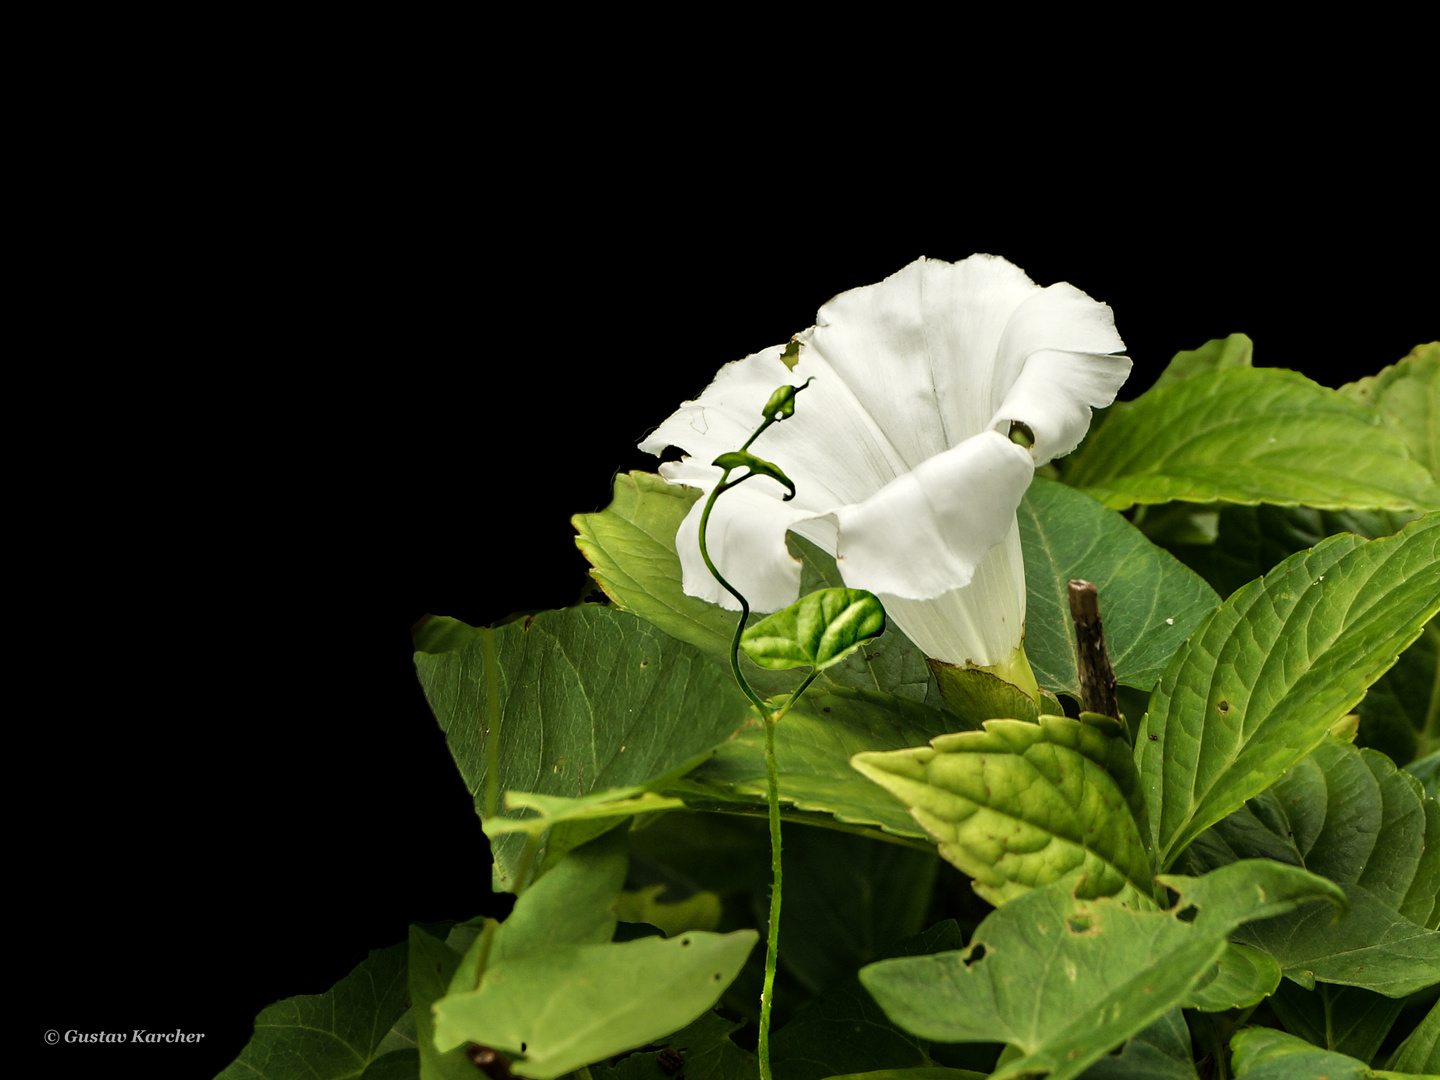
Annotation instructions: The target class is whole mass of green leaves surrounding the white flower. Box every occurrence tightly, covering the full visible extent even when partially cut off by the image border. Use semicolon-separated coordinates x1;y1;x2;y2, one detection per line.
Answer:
222;336;1440;1080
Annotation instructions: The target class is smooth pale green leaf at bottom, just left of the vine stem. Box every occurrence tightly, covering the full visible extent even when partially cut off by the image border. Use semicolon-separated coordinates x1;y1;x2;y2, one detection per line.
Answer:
435;930;759;1080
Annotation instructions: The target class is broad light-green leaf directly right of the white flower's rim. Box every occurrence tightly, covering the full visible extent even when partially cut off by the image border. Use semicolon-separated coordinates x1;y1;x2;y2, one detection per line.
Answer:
1064;366;1440;510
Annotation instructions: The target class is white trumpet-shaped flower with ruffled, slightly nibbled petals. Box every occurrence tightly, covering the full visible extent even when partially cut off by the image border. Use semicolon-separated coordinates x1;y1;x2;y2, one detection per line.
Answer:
641;255;1130;667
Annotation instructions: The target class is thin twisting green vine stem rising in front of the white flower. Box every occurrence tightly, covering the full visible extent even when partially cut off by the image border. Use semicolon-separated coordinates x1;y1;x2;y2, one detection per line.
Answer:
700;379;819;1080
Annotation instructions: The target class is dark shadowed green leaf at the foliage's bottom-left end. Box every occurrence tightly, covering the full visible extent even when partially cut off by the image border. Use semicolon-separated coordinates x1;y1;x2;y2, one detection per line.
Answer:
216;942;419;1080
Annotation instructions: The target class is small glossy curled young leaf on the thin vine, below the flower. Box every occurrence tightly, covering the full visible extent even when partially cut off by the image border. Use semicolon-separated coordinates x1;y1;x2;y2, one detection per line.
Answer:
740;589;886;671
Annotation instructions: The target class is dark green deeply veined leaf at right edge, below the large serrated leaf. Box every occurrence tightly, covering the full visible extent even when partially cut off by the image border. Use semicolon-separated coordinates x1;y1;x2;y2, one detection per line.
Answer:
1187;739;1440;996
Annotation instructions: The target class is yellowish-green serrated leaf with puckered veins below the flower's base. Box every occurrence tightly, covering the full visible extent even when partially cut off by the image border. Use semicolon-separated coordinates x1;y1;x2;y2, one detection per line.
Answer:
852;716;1155;907
